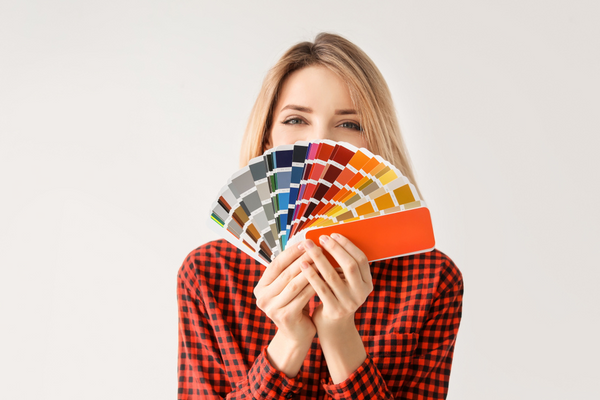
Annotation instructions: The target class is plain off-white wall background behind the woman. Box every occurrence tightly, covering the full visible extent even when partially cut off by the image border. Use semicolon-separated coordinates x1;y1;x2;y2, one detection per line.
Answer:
0;0;600;400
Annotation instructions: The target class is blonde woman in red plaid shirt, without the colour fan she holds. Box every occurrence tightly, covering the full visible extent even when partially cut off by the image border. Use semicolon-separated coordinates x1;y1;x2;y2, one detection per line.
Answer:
178;33;463;399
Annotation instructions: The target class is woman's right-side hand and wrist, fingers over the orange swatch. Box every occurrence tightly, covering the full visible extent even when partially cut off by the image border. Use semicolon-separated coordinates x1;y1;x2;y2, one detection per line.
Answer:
301;234;373;384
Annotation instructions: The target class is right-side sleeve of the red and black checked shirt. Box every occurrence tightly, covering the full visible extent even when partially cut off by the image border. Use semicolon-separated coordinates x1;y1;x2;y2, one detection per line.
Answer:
322;261;463;399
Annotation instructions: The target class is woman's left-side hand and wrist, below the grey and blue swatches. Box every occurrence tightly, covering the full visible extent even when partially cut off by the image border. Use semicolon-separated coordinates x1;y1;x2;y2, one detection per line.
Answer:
254;242;316;378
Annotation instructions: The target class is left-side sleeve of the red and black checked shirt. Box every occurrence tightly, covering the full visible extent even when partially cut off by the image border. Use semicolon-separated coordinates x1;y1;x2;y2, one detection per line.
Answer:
177;264;302;400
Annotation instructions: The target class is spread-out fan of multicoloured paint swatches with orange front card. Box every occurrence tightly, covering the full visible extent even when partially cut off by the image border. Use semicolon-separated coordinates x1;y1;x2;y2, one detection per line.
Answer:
209;140;435;265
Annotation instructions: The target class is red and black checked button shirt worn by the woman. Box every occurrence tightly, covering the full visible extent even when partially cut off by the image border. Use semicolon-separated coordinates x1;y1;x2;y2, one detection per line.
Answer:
177;240;463;400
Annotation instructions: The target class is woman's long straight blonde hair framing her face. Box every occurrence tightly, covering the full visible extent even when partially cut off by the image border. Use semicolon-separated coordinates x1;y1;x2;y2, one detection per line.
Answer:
240;32;419;198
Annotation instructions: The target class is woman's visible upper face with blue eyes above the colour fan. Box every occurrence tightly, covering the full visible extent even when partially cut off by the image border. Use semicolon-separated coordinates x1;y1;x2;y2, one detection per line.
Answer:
266;66;367;149
